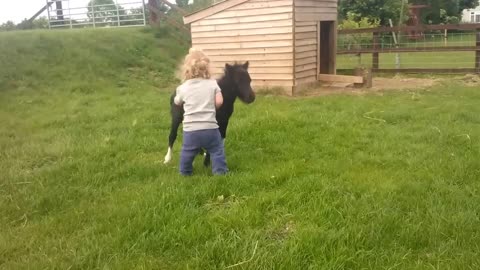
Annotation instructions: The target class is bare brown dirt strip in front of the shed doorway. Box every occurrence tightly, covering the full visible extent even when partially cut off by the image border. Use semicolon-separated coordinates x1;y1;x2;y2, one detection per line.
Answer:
297;76;443;96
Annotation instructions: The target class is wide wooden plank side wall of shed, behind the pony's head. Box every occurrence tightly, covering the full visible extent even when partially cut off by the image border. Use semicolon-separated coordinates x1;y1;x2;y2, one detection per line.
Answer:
191;0;294;89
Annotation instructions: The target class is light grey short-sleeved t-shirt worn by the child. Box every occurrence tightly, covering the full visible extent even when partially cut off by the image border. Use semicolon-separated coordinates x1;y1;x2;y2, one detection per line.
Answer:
174;79;221;131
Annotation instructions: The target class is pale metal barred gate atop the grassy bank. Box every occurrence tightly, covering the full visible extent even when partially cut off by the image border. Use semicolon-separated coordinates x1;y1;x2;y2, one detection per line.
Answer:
46;0;146;29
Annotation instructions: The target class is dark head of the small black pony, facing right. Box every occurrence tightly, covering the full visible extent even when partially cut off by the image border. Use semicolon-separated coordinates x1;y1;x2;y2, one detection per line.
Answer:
224;61;255;104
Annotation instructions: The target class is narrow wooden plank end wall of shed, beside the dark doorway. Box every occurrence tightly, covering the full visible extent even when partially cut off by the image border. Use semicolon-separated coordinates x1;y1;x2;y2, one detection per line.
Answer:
294;0;337;86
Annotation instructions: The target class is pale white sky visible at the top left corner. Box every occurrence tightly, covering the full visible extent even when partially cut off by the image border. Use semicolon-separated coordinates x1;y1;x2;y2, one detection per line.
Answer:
0;0;158;24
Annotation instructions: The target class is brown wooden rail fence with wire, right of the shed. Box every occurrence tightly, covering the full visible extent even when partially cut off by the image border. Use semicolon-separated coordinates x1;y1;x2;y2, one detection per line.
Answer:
337;25;480;72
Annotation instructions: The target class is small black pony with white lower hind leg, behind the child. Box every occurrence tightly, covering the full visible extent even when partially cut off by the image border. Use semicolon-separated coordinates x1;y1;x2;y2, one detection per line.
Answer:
164;61;255;166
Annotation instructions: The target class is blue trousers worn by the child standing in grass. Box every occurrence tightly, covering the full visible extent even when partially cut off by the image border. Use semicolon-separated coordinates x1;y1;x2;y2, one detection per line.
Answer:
180;129;228;175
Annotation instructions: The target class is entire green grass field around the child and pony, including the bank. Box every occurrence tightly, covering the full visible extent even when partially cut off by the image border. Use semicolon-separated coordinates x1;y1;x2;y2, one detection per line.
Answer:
0;26;480;270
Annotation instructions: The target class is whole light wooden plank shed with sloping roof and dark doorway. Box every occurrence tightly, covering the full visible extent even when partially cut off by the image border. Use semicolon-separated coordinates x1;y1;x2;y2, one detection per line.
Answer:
184;0;338;95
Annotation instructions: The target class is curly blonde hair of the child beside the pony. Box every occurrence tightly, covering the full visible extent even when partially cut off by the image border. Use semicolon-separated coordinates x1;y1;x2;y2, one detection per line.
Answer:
181;48;211;81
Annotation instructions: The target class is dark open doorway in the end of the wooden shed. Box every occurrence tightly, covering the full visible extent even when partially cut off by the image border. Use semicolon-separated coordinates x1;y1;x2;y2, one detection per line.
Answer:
317;21;336;74
